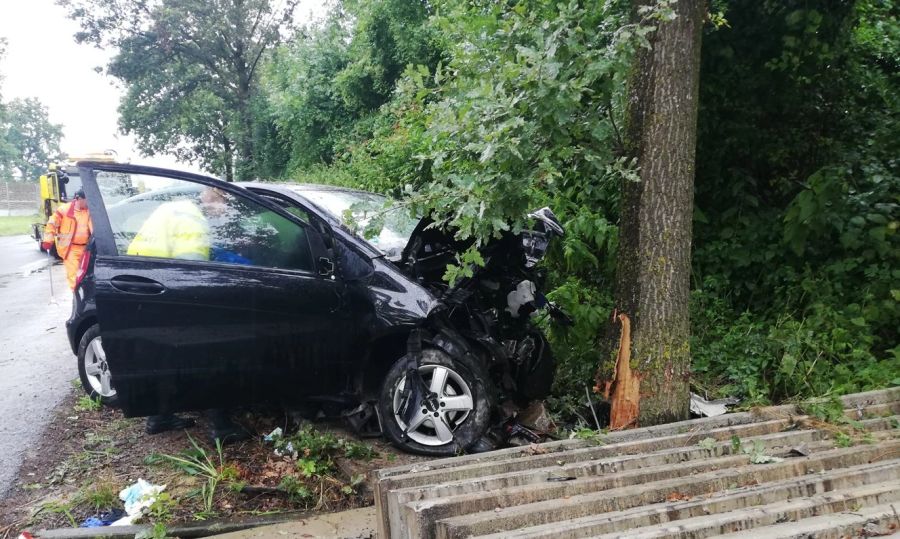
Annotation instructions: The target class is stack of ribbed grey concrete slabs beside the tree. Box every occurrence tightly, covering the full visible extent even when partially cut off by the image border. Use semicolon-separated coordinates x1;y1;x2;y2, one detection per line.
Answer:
372;388;900;538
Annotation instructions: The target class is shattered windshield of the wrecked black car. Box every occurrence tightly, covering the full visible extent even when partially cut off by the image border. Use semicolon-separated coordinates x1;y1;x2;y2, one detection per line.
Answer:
292;186;419;260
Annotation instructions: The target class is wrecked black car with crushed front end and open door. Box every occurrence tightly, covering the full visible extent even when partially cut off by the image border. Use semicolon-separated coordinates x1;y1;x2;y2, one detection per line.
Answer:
67;162;564;455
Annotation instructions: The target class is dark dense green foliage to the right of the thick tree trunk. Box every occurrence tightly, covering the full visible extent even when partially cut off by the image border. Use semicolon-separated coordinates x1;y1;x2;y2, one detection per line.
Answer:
692;1;900;403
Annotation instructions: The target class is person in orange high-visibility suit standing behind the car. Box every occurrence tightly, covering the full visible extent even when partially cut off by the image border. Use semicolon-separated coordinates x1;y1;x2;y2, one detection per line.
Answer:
41;189;94;290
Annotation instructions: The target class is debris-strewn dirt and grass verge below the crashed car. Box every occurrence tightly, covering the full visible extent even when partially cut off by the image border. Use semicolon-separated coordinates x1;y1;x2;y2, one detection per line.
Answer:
0;387;425;539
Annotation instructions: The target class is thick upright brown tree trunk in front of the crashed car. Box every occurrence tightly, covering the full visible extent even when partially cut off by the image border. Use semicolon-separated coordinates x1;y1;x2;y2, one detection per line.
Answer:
616;0;706;426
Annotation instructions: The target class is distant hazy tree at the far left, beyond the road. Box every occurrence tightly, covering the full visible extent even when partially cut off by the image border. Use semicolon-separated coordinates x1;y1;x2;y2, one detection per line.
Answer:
0;97;62;181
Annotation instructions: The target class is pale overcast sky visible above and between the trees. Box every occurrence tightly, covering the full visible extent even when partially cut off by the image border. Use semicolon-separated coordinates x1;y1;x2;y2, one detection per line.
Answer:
0;0;325;175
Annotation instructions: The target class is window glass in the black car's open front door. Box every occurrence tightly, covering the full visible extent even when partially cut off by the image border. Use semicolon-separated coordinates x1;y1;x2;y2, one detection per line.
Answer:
97;171;314;271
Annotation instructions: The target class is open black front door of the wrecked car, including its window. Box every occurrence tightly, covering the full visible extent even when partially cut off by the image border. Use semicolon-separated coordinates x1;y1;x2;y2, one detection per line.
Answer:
81;164;349;416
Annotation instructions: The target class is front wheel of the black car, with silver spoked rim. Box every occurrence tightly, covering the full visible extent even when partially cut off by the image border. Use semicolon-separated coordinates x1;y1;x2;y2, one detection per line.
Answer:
378;348;494;457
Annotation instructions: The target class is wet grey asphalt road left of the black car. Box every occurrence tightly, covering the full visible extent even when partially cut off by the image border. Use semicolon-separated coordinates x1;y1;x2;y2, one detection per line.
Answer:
0;236;78;497
